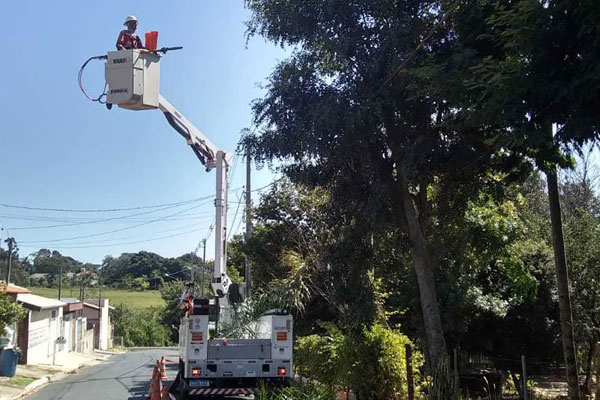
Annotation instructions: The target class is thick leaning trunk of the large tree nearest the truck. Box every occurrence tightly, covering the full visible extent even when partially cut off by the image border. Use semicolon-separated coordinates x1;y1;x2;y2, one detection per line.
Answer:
398;165;447;371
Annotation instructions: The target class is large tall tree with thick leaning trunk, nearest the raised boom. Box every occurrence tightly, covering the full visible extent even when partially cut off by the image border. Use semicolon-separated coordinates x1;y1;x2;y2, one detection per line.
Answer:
244;0;518;365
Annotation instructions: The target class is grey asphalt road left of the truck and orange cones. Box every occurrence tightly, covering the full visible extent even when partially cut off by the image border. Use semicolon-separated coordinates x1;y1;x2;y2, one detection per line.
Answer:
27;349;177;400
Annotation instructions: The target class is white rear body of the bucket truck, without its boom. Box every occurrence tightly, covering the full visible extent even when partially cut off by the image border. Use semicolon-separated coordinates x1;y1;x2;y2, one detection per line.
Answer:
179;307;293;394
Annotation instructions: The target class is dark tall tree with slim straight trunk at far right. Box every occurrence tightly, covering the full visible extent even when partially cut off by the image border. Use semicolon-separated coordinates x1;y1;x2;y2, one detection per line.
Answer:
455;0;600;400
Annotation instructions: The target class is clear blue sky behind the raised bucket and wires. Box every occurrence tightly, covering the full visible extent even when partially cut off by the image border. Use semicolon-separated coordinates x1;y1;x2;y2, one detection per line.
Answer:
0;0;286;263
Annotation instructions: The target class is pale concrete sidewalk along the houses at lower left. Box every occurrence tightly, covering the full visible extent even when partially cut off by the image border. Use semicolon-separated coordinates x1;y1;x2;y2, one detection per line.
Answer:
0;353;110;400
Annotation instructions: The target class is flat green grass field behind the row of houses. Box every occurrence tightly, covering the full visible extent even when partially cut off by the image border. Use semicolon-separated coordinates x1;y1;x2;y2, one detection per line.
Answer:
31;287;165;308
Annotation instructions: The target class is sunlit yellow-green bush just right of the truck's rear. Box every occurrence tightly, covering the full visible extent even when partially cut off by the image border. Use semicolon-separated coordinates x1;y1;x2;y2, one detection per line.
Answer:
295;323;423;400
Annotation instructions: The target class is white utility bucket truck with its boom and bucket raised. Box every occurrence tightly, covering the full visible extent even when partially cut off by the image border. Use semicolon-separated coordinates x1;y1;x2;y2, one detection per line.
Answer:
96;48;293;398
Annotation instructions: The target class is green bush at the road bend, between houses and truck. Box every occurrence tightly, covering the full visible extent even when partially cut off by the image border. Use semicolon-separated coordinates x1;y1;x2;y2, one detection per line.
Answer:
113;304;171;347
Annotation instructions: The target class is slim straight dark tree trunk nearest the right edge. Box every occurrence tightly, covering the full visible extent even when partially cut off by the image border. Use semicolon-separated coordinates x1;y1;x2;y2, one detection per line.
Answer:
545;161;581;400
